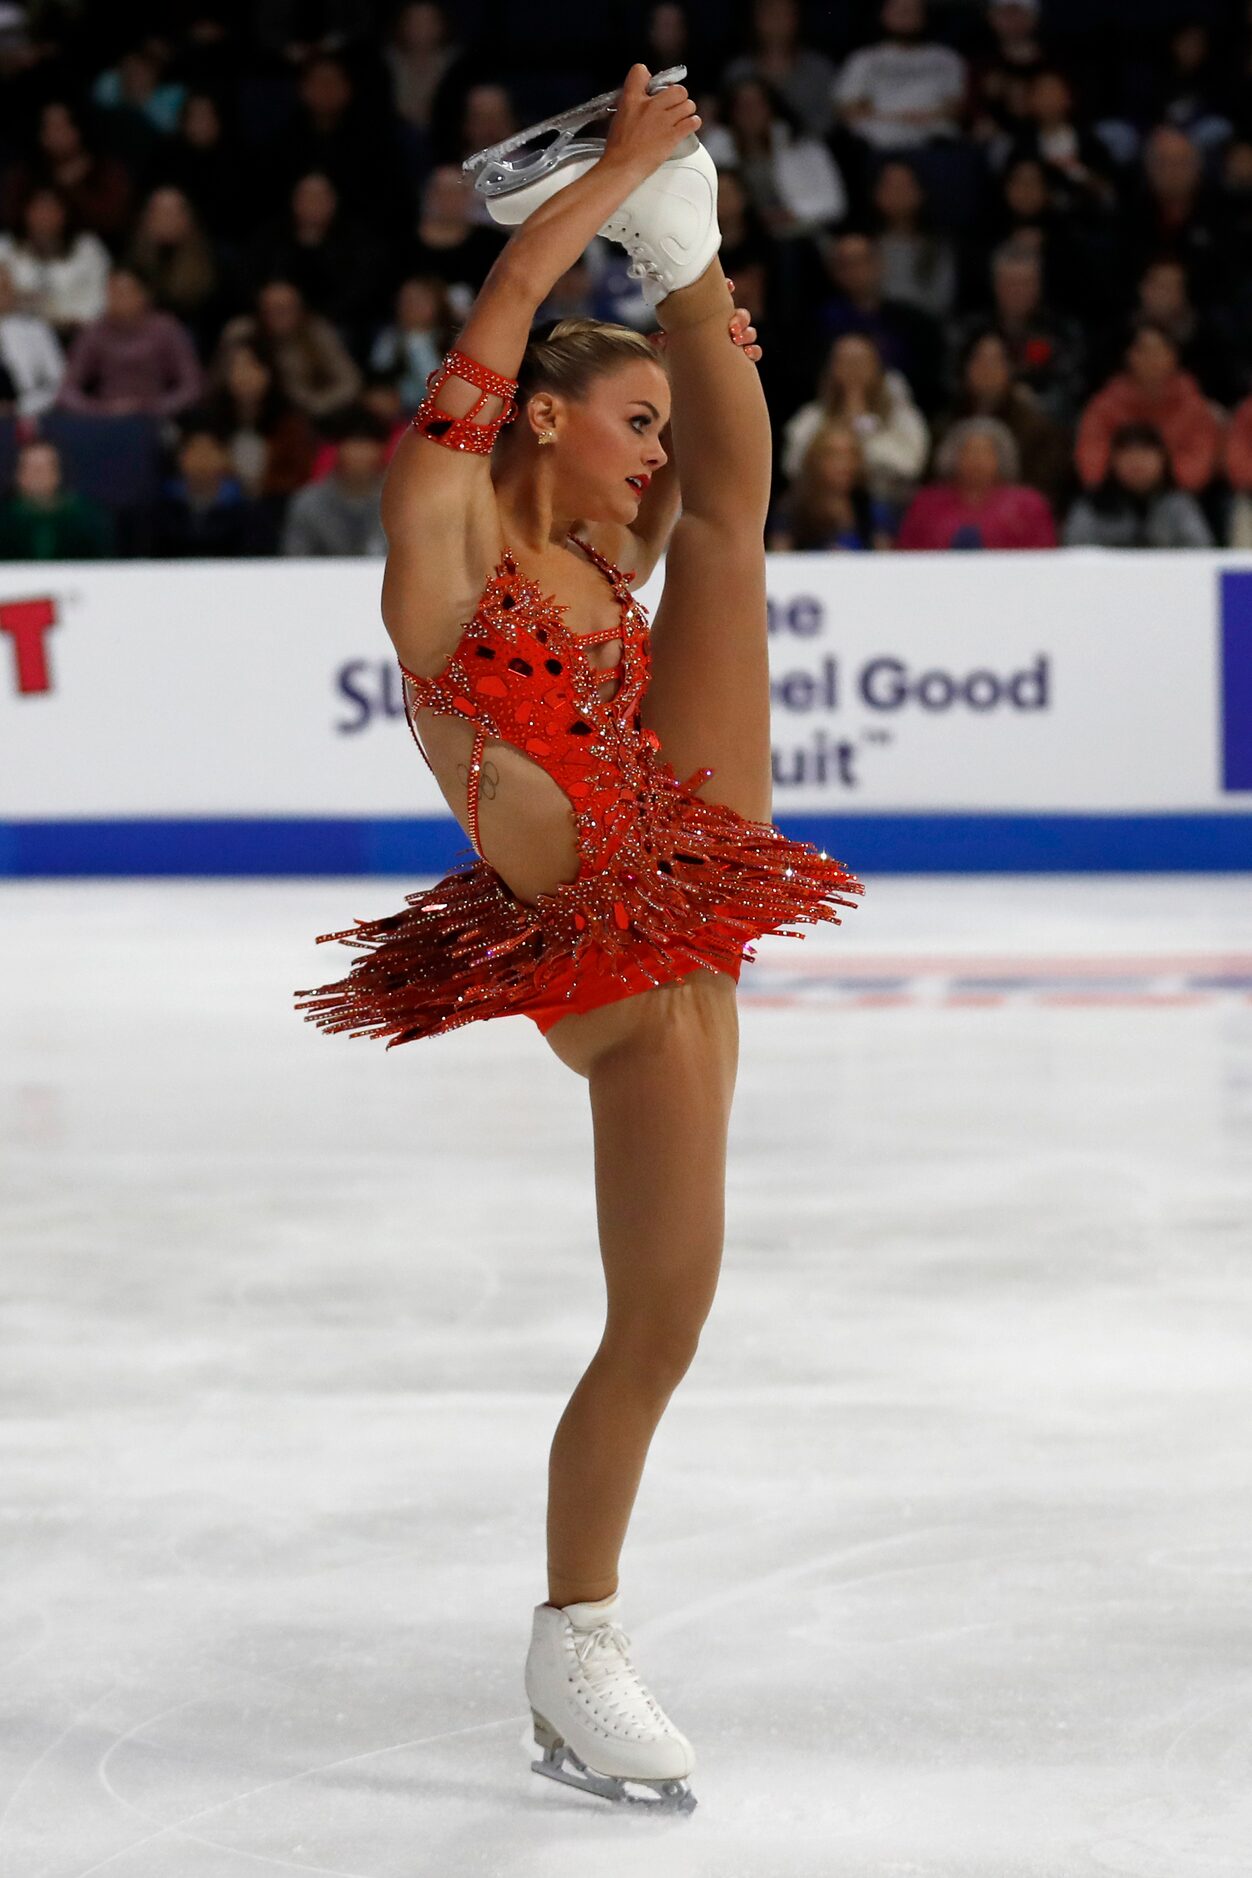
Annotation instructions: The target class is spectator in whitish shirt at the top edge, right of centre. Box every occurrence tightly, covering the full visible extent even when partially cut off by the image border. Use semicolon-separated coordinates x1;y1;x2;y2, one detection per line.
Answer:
835;0;969;150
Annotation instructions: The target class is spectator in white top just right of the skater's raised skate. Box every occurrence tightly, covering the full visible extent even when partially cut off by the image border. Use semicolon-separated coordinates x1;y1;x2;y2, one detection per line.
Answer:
702;77;848;240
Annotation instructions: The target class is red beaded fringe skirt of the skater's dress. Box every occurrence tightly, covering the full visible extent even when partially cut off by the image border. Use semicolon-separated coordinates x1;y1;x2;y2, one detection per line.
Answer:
297;772;863;1048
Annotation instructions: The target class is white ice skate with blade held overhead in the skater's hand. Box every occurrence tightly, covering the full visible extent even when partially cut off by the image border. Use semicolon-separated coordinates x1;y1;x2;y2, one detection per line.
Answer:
464;66;721;306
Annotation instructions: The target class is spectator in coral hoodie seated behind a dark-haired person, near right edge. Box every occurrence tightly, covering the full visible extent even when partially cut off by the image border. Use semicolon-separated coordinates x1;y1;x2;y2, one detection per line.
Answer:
1076;319;1222;494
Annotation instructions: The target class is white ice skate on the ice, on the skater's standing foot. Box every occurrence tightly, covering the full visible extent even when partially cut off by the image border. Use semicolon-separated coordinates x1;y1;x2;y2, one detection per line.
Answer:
526;1593;696;1812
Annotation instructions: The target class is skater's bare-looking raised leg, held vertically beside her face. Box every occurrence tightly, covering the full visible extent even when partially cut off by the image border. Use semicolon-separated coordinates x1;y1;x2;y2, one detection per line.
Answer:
644;261;771;821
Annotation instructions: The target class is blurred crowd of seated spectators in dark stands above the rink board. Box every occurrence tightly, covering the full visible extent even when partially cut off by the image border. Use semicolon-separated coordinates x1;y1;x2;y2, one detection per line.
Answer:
0;0;1252;560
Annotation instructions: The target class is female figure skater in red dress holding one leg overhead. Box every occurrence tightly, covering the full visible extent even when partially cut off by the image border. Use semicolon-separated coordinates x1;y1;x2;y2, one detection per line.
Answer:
300;66;862;1810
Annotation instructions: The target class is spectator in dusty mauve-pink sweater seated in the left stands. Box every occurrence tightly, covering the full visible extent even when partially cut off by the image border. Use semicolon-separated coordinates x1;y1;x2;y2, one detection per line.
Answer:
60;267;203;417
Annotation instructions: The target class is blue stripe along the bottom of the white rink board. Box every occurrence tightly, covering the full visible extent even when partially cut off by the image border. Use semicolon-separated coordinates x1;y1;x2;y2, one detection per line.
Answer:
0;815;1252;877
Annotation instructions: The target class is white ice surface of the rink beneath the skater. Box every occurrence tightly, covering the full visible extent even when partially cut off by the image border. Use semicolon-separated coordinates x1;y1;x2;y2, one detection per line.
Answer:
0;877;1252;1878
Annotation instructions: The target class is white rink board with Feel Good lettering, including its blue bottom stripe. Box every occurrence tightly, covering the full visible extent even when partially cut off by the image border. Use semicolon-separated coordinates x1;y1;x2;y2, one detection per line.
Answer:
0;552;1252;875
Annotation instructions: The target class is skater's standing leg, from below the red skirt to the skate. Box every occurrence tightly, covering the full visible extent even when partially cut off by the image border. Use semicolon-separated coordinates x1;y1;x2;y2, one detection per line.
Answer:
548;971;738;1606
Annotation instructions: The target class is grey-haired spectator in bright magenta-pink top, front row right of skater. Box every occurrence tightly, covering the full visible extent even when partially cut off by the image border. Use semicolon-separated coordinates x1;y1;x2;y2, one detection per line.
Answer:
895;417;1057;550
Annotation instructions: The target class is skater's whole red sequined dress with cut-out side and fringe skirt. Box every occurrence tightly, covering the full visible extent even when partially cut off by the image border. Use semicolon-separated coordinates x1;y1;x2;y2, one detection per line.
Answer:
298;535;863;1046
